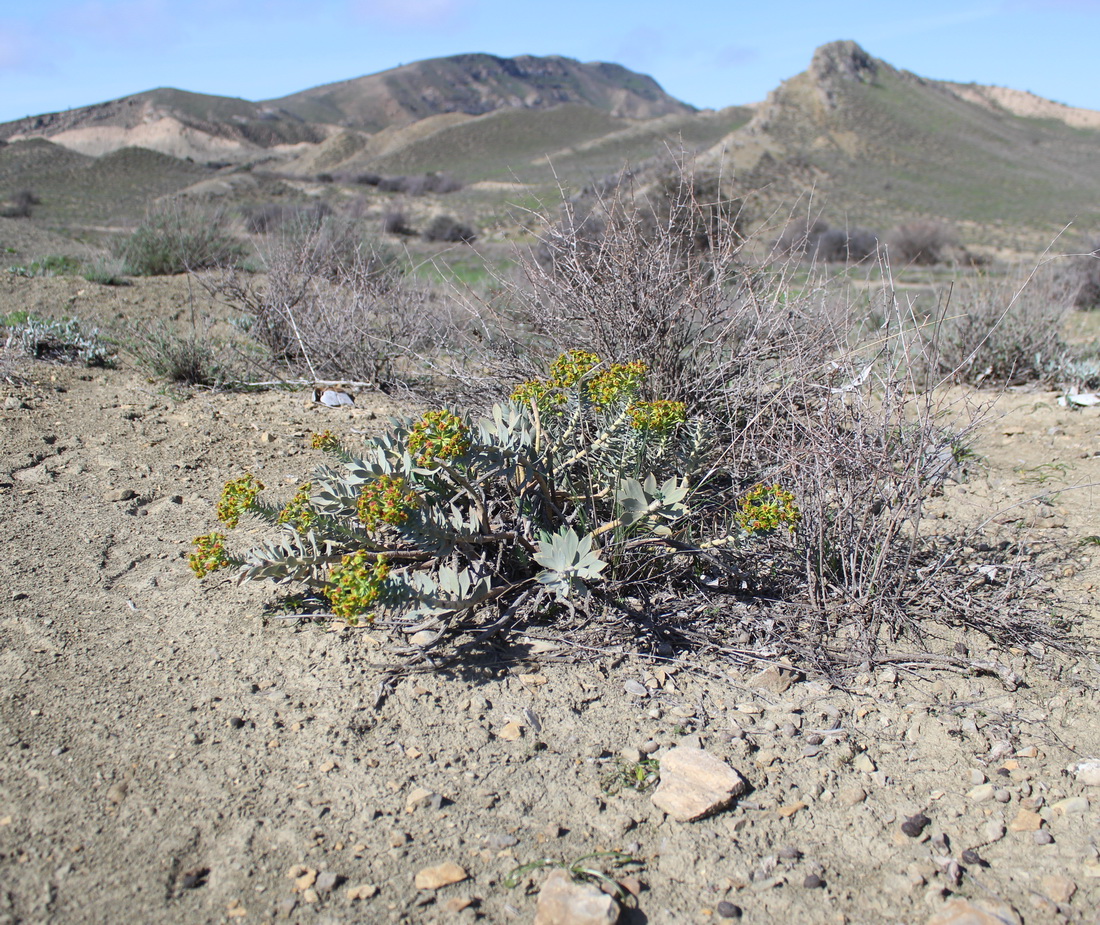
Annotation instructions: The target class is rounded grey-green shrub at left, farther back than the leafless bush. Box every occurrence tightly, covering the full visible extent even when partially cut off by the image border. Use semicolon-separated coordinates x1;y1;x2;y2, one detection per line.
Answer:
114;200;246;276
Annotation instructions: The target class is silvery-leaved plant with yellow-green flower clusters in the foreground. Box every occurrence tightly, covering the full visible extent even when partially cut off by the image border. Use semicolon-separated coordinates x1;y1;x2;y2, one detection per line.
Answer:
193;351;798;638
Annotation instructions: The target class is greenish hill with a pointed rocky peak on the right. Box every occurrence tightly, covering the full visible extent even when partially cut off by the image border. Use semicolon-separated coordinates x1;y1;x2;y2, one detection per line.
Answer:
705;42;1100;240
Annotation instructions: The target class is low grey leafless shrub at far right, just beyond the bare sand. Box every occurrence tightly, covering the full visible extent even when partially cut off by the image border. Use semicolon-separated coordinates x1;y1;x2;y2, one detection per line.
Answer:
924;267;1068;385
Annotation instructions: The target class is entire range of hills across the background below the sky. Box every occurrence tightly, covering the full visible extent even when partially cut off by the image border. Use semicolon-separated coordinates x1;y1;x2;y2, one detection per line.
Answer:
0;42;1100;249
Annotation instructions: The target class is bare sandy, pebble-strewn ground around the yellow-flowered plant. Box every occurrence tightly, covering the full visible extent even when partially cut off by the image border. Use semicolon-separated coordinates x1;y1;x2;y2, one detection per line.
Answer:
0;277;1100;925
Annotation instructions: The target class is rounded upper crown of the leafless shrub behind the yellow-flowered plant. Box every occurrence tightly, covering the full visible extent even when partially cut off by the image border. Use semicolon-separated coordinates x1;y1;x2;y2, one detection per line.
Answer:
451;167;796;411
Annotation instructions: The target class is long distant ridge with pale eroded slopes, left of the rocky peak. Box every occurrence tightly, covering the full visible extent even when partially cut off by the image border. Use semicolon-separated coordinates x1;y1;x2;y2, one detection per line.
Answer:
0;54;694;163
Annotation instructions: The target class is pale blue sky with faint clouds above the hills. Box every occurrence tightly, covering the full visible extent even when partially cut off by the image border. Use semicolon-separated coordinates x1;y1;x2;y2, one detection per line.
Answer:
0;0;1100;121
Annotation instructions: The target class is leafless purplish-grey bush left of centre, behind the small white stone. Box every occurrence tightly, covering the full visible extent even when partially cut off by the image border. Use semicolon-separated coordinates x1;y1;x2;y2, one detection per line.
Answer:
204;222;439;385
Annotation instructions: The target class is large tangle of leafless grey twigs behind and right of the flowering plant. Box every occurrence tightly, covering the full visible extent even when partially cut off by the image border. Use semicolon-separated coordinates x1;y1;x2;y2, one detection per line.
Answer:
431;177;1073;667
